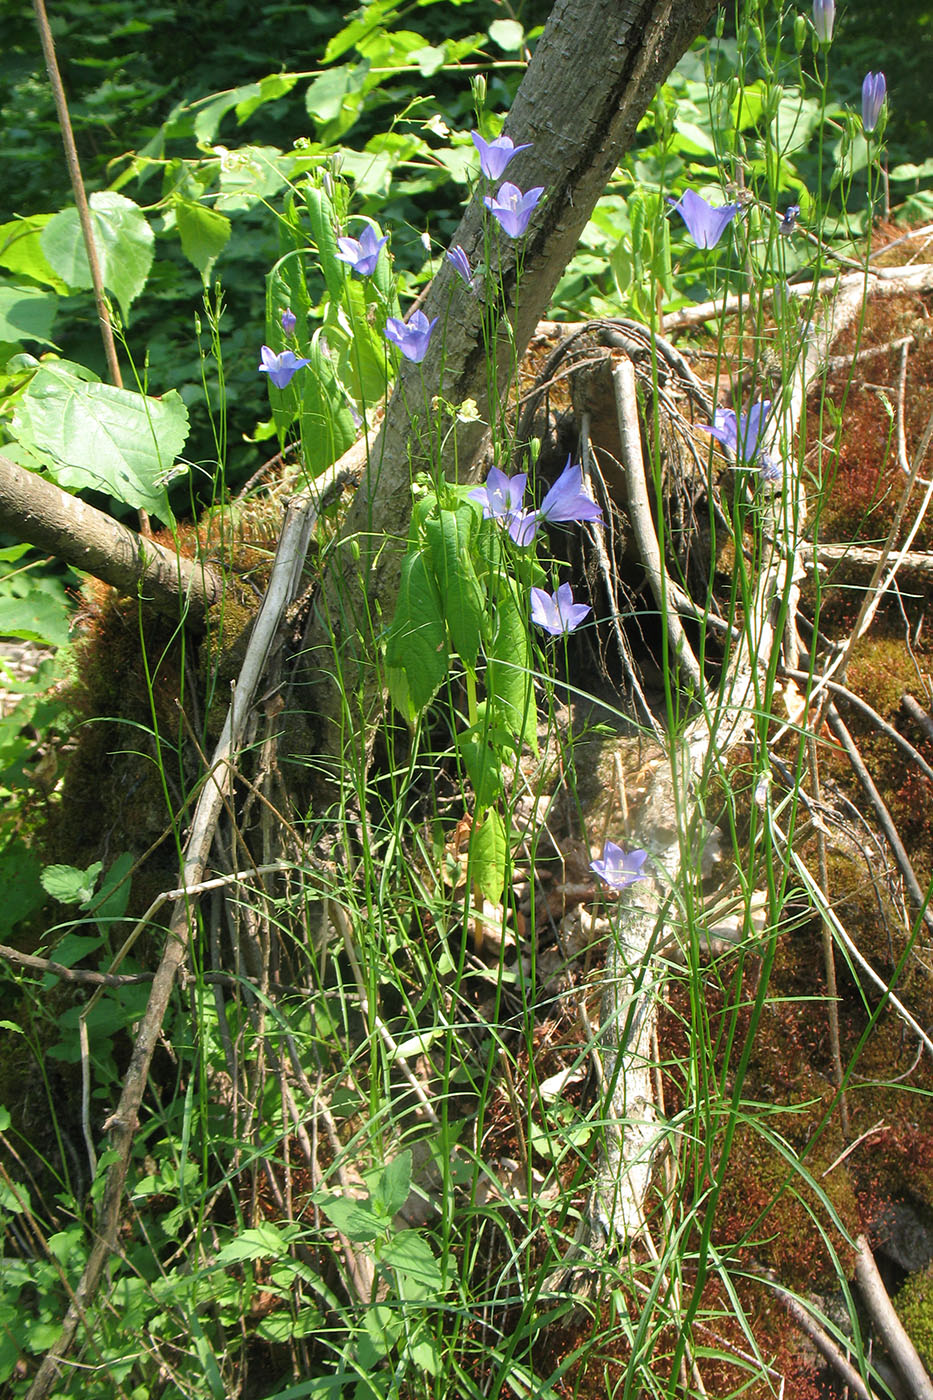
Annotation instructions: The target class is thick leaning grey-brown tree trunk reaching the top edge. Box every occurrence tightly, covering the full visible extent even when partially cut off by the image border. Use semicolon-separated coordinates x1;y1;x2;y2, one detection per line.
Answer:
293;0;714;764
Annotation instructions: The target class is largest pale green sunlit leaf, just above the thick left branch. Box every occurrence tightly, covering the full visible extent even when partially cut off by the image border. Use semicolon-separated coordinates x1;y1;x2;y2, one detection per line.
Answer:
13;363;188;521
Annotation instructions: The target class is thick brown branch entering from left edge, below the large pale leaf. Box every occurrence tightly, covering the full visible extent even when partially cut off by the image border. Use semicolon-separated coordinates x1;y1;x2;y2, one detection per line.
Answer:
0;456;223;629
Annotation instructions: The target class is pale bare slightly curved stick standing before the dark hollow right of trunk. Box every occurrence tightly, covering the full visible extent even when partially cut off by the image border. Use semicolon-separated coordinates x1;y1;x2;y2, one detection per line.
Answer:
612;356;703;694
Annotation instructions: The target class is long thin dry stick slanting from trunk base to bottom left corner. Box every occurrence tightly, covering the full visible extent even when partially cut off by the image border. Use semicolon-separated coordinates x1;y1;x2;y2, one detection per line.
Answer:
27;498;326;1400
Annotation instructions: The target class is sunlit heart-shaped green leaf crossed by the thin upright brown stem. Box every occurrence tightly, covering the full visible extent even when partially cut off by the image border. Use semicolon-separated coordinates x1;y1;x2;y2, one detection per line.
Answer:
41;190;156;318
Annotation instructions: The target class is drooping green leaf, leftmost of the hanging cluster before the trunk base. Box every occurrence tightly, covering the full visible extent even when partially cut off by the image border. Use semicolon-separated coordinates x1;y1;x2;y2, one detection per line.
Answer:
385;552;448;720
